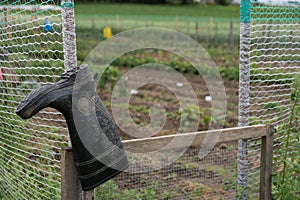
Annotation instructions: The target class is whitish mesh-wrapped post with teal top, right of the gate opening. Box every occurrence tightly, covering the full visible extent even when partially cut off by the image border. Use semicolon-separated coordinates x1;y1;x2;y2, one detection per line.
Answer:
237;0;251;199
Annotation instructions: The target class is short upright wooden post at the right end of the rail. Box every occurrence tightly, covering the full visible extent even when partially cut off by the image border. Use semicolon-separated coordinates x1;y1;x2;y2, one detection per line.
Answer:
259;126;274;200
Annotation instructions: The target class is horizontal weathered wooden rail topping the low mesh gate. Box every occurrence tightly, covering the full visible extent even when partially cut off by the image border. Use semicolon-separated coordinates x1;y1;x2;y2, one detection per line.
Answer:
123;125;274;152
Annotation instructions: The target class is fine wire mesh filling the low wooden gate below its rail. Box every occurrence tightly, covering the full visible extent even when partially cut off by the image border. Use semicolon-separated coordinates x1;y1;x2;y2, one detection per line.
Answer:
95;141;246;200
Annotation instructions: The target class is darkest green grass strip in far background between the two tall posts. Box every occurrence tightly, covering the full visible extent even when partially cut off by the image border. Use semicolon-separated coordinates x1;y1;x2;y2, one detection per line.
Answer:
75;3;239;18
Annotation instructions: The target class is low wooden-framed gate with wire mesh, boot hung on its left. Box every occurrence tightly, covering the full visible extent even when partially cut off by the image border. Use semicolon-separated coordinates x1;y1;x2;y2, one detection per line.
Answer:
62;125;274;200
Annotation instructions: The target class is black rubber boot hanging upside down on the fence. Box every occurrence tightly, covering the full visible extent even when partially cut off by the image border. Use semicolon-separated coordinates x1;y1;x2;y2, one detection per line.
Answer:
16;66;128;190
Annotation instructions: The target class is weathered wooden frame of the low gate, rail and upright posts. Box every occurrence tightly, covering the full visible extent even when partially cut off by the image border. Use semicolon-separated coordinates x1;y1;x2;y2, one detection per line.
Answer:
61;125;274;200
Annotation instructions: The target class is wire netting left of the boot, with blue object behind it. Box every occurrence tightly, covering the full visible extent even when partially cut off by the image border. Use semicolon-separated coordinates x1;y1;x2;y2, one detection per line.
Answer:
0;0;68;199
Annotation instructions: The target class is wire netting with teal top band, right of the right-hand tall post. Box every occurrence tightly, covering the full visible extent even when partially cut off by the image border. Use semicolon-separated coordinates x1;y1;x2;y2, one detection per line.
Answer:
250;1;300;130
